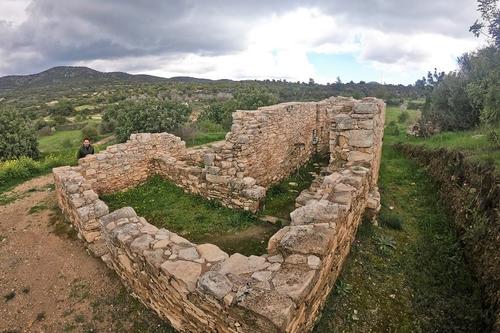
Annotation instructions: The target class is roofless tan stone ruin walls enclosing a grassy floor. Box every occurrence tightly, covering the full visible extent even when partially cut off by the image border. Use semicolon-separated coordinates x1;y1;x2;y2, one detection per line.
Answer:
53;97;385;333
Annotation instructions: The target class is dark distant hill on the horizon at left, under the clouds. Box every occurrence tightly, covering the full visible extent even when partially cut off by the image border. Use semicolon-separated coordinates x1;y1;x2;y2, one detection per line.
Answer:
0;66;219;93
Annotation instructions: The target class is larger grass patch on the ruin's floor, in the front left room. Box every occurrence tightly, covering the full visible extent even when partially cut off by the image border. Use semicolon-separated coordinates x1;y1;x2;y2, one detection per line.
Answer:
101;176;281;255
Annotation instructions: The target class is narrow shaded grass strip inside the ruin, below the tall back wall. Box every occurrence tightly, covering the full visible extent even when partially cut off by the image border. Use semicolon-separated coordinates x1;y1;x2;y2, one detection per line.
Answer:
262;156;329;220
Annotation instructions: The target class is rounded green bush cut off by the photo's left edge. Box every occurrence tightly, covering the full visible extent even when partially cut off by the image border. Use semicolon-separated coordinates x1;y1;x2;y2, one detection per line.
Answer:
0;108;40;161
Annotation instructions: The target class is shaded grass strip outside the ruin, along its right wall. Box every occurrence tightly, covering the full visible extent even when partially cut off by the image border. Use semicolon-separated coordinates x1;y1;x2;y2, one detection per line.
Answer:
314;146;484;333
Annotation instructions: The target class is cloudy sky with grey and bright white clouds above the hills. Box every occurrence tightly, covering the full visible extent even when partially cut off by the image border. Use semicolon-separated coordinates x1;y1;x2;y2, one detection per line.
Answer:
0;0;481;84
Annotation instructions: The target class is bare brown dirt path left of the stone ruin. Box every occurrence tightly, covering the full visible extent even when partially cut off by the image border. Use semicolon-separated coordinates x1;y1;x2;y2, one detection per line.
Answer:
0;175;171;333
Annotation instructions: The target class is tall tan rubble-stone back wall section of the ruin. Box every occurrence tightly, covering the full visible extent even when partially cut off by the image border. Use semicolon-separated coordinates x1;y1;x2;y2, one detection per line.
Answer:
218;102;328;187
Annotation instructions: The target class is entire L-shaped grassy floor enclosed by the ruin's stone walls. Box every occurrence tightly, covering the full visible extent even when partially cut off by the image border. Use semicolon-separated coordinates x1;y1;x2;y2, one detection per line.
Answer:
100;155;328;256
